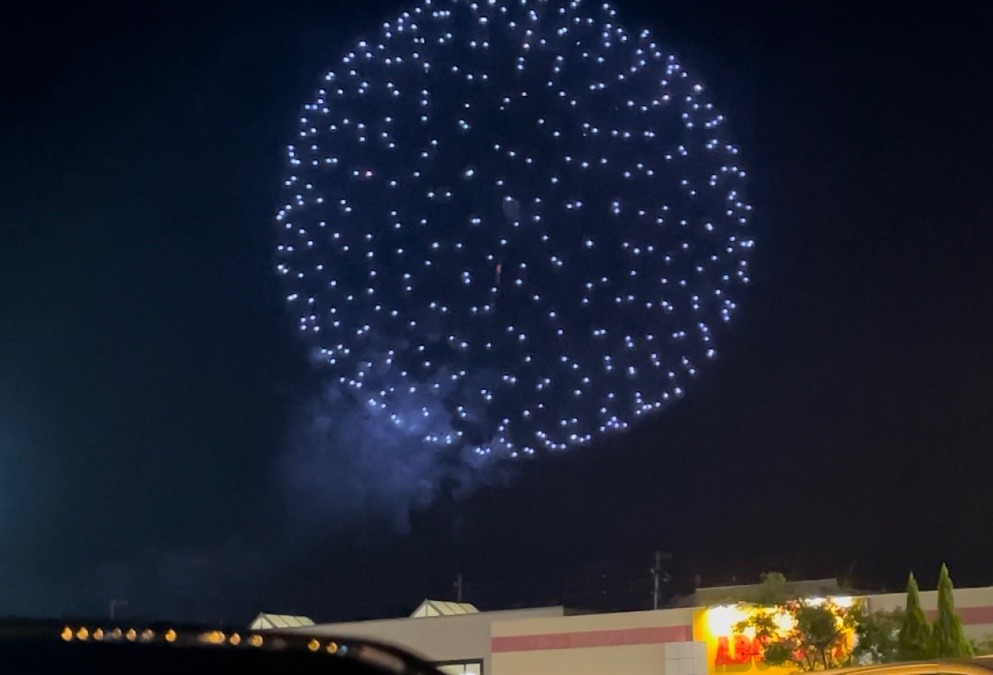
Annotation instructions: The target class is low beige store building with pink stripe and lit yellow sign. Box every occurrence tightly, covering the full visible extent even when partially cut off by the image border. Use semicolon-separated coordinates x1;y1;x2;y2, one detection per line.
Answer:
258;582;993;675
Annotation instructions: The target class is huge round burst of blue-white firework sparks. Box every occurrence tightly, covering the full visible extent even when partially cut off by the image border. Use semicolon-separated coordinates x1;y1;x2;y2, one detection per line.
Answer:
276;0;752;464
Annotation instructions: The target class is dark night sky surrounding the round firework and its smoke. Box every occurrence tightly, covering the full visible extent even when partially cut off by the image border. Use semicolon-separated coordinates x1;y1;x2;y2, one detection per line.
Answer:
0;0;993;621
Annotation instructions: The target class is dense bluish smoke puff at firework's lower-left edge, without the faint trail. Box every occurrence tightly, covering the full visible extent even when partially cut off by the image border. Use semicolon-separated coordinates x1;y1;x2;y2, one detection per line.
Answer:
279;375;511;533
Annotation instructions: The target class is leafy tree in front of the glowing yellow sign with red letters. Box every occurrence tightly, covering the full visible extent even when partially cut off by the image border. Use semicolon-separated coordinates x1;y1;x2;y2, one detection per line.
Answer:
736;598;860;671
